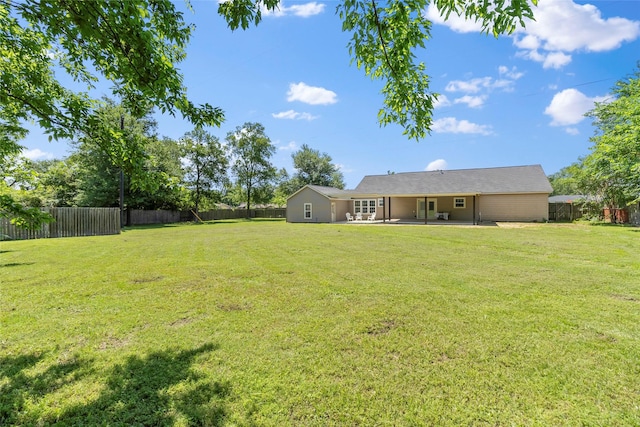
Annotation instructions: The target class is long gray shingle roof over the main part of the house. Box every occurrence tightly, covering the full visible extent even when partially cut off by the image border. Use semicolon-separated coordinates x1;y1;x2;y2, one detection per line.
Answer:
355;165;553;196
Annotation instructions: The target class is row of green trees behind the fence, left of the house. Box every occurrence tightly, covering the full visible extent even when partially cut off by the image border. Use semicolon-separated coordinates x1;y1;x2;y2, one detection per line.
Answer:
0;100;344;219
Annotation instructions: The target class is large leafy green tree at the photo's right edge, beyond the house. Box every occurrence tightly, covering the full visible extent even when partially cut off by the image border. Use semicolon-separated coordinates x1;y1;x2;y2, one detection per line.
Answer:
584;64;640;208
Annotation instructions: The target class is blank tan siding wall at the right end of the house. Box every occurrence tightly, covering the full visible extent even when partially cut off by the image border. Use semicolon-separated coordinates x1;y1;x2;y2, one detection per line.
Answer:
476;193;549;222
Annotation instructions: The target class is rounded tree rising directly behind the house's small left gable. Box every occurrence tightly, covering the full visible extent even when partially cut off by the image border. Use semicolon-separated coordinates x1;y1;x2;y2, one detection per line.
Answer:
291;144;344;191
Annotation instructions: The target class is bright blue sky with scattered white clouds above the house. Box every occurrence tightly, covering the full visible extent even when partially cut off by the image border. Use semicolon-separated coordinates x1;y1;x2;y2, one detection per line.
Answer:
22;0;640;188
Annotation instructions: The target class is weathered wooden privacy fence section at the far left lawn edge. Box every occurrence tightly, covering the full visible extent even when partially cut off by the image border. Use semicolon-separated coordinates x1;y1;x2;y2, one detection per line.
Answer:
0;208;120;240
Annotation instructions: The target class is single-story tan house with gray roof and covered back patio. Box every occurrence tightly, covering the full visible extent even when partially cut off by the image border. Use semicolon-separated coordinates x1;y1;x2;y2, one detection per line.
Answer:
287;165;553;224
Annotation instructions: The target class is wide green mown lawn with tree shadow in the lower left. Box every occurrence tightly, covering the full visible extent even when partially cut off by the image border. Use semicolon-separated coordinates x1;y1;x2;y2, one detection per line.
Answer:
0;220;640;426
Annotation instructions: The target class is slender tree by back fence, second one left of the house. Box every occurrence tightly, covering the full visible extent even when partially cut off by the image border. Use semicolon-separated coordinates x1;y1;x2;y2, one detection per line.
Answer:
180;128;229;214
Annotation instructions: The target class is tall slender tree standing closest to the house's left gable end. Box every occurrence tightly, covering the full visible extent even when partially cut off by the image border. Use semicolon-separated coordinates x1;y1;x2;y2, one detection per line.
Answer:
226;123;276;217
